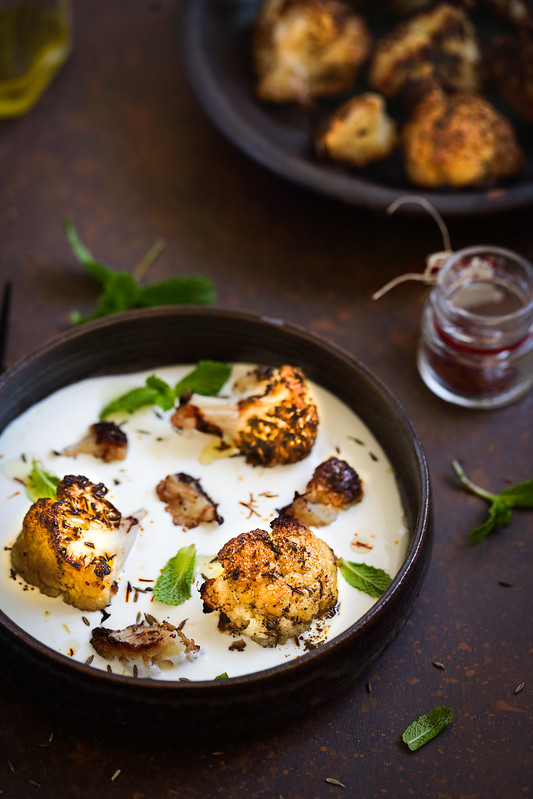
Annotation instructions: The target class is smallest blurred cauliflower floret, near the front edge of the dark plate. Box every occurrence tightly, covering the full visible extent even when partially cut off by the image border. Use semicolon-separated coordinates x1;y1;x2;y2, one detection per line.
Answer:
317;92;397;167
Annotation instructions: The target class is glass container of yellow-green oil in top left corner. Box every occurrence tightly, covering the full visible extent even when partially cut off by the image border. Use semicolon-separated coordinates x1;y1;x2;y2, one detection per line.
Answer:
0;0;72;117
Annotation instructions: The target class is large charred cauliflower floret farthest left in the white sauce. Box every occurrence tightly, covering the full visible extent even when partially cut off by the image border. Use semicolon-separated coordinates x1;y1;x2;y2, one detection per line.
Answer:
11;475;138;610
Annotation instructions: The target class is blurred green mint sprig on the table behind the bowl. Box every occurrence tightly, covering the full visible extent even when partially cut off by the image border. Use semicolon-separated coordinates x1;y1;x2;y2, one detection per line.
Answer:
64;219;216;324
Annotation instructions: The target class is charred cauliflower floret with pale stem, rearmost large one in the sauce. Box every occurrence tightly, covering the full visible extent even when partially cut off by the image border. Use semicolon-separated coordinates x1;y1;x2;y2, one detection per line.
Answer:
171;366;318;466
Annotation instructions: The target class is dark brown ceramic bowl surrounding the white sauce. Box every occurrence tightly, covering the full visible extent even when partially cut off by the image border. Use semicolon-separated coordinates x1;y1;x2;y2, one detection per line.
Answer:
0;308;432;735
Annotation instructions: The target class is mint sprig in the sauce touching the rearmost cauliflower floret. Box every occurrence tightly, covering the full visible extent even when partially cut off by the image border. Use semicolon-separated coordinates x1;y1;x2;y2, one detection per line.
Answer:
100;361;231;419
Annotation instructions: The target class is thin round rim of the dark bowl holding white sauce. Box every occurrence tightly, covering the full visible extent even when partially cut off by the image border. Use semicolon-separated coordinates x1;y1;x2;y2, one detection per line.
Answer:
0;306;432;693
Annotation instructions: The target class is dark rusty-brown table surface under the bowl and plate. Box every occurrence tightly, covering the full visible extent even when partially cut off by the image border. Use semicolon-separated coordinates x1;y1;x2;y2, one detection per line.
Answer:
0;0;533;799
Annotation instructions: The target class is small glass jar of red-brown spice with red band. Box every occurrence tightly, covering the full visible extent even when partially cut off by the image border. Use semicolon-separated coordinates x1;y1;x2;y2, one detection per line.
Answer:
418;246;533;408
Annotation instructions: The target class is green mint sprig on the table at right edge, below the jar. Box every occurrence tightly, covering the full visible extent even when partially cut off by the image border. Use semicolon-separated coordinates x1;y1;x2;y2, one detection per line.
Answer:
452;460;533;544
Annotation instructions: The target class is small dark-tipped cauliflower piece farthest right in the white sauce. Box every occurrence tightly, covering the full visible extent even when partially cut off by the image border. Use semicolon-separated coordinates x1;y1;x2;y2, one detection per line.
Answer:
283;457;363;527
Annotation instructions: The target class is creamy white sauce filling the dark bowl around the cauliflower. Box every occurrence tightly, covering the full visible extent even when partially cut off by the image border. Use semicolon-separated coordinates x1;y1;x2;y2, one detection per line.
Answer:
0;364;408;680
